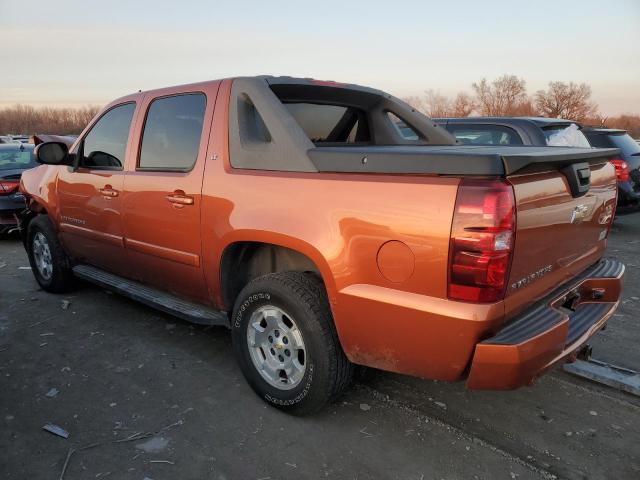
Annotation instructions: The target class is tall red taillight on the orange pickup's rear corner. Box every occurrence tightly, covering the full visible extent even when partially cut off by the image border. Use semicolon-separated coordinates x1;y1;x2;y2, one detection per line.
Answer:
448;180;516;302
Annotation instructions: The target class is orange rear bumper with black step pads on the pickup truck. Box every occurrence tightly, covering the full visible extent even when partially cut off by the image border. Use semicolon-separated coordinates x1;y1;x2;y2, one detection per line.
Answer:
467;259;625;390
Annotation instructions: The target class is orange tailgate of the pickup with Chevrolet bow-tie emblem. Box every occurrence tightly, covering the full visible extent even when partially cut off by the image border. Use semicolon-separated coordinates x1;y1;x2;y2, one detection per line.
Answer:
505;161;617;318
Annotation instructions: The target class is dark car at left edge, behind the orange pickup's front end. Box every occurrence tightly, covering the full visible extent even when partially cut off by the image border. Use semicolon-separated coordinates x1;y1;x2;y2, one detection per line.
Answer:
0;143;39;234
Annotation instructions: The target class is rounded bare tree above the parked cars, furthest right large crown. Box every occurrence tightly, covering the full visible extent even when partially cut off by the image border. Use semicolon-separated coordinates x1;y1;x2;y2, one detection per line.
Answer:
535;82;597;121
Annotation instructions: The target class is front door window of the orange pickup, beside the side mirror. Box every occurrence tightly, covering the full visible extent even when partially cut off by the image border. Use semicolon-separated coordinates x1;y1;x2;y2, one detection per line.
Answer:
80;103;136;170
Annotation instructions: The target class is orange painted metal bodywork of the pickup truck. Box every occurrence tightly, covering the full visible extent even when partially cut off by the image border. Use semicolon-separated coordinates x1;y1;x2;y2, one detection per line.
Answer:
22;76;617;388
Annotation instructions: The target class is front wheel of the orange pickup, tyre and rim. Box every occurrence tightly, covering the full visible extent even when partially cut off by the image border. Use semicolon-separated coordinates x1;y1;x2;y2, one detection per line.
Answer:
26;215;74;293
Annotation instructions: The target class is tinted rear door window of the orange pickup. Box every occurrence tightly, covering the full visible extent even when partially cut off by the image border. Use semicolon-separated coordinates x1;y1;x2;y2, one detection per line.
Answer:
138;93;207;171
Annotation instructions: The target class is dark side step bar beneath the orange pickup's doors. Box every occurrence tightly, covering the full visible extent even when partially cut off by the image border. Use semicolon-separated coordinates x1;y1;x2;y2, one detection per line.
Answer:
73;265;230;327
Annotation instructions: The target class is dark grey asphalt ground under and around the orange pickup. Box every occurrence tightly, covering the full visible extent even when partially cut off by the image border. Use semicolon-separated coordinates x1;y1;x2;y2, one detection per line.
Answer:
0;214;640;480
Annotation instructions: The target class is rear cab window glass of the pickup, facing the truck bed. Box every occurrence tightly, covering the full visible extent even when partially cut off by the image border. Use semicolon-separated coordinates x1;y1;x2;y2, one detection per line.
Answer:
284;103;371;143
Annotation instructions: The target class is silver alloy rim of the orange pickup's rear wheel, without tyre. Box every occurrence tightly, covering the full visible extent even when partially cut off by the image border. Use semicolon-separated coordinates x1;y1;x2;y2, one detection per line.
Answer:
247;305;306;390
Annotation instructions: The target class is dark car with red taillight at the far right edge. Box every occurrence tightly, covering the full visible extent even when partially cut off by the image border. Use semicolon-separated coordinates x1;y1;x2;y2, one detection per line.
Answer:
582;127;640;207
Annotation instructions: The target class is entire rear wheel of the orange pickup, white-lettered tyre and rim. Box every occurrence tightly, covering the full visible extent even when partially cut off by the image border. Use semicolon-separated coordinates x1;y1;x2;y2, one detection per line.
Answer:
231;272;353;415
